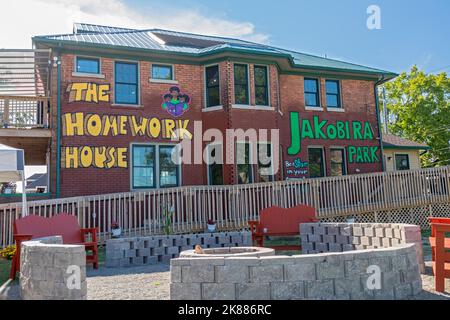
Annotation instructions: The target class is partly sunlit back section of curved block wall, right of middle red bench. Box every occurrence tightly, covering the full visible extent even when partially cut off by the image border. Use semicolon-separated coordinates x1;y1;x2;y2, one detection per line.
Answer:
300;223;425;273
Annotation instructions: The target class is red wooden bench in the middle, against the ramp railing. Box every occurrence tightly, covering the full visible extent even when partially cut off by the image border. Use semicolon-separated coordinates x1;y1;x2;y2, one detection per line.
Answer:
248;205;318;250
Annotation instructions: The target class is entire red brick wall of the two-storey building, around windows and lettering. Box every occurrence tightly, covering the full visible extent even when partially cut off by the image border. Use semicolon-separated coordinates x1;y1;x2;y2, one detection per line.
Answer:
51;54;381;196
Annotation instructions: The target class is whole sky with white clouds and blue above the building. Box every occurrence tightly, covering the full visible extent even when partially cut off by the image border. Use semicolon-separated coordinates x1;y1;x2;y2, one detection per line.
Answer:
0;0;450;72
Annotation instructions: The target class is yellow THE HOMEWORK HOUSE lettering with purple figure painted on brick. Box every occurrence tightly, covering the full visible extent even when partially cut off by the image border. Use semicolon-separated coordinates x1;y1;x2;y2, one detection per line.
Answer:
61;82;192;169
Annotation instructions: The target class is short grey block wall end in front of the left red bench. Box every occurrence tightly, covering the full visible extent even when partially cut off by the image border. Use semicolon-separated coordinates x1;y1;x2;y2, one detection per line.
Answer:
19;236;87;300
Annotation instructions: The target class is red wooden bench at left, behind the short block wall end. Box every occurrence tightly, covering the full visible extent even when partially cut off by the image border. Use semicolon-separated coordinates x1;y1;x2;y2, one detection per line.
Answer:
10;213;98;279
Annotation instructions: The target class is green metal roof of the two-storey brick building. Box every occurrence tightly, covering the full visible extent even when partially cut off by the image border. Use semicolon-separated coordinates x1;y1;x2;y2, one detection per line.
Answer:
33;23;397;80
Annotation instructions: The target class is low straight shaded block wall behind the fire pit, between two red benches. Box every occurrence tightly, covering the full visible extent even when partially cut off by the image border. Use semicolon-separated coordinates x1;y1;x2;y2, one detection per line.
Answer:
106;231;252;268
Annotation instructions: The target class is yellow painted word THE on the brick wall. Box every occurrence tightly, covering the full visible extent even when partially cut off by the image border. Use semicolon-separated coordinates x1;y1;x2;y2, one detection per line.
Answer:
66;82;110;103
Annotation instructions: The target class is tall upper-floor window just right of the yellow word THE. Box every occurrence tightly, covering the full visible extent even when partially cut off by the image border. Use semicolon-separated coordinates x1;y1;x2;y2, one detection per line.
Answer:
114;62;139;104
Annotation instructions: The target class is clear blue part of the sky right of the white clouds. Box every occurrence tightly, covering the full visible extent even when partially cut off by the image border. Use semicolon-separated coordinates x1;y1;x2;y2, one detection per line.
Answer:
127;0;450;72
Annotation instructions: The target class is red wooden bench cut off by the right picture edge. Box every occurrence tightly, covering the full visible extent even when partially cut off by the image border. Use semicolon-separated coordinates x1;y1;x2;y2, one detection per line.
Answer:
428;218;450;292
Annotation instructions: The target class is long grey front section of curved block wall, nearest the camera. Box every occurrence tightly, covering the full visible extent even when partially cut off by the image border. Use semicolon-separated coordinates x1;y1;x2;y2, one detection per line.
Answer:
170;244;422;300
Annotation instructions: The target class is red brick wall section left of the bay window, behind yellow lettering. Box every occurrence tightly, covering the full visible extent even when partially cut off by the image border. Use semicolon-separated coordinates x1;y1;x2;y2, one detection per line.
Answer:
56;55;204;196
